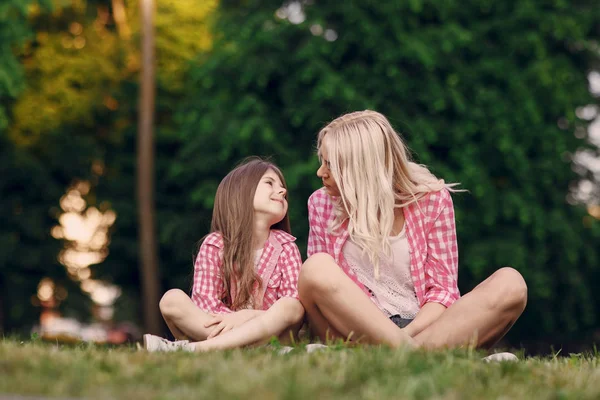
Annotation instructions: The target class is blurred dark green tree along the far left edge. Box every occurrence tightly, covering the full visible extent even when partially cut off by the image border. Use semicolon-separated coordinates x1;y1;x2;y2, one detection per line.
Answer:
0;0;84;332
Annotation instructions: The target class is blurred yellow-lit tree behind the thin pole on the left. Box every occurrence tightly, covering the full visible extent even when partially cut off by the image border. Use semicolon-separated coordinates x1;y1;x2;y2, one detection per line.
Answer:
7;0;216;332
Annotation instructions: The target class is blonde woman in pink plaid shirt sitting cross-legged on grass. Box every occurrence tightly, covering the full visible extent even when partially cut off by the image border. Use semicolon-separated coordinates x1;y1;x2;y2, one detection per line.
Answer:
298;110;527;356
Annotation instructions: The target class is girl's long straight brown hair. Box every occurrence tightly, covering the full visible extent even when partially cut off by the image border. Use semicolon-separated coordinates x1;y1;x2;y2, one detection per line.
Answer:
210;157;291;310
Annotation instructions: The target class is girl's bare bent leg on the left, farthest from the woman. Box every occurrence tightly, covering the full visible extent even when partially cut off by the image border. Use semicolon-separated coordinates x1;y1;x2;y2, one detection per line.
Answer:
159;289;216;340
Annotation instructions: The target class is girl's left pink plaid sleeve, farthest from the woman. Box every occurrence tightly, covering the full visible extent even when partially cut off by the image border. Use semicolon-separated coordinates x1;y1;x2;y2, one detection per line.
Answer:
192;243;232;314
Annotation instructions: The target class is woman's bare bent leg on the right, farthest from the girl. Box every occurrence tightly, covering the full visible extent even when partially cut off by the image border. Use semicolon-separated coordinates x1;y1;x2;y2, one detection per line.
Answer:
414;268;527;348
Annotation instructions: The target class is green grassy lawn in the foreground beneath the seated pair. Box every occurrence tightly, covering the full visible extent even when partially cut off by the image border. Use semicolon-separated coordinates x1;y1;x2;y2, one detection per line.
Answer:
0;339;600;400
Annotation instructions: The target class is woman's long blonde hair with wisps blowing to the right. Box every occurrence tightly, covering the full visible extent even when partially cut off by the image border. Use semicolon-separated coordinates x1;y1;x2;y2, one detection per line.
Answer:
317;110;456;278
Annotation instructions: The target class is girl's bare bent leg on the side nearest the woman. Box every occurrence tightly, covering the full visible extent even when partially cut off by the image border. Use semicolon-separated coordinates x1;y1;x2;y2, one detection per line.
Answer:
191;297;304;351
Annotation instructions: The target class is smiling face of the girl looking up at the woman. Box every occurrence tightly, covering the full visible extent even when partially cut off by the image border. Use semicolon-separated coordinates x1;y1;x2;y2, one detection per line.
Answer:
254;169;288;225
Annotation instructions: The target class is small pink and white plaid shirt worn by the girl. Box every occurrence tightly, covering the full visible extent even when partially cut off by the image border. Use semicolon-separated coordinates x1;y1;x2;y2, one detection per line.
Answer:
192;229;302;314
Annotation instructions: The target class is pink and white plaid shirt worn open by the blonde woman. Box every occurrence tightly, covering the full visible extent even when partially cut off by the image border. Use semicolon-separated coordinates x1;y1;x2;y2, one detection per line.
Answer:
307;188;460;307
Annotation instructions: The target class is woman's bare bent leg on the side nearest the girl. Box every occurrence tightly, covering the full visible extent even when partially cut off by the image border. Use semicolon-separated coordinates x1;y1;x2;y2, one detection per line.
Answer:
298;253;413;347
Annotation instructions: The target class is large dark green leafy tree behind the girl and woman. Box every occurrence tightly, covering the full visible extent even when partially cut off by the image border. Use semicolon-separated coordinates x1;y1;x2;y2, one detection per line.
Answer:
170;0;600;345
